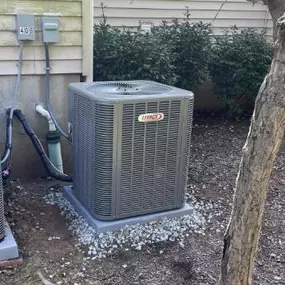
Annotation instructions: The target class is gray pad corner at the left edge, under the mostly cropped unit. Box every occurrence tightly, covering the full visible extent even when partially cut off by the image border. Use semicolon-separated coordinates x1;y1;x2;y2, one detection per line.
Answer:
0;223;19;263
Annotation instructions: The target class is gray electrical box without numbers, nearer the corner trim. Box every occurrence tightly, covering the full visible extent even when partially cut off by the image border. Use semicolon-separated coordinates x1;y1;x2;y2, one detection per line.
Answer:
42;17;59;43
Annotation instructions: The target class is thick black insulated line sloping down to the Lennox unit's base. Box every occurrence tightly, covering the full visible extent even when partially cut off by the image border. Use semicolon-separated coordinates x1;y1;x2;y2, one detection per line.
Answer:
14;109;72;182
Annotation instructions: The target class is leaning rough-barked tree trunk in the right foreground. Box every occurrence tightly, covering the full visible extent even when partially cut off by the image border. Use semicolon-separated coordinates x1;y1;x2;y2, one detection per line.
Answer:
219;14;285;285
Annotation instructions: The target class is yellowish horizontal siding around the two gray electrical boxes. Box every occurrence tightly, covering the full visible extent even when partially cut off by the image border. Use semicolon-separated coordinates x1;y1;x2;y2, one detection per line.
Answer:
0;0;85;75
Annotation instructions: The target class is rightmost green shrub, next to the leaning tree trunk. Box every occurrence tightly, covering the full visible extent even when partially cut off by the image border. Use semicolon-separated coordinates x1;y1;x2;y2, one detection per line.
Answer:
209;28;272;116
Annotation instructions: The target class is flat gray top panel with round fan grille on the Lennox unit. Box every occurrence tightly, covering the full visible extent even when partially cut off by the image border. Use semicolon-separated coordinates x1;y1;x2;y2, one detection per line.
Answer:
69;80;191;104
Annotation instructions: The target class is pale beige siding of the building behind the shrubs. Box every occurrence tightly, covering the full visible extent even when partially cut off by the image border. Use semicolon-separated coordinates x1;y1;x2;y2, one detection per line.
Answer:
94;0;272;36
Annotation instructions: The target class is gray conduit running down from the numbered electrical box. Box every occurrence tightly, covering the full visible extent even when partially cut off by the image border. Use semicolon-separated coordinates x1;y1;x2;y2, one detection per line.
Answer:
1;42;24;164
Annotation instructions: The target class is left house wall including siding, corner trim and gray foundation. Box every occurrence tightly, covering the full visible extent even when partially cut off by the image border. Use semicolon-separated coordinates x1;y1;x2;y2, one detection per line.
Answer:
0;0;93;178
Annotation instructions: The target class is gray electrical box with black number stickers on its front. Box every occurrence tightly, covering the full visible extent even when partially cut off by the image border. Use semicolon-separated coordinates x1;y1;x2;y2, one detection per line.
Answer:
17;14;36;41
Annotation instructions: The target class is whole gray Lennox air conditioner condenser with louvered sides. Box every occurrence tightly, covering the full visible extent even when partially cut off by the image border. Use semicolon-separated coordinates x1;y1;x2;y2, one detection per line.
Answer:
69;81;194;221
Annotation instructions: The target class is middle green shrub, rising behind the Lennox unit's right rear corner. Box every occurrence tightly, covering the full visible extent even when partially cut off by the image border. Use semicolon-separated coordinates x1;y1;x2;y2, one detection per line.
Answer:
154;10;212;90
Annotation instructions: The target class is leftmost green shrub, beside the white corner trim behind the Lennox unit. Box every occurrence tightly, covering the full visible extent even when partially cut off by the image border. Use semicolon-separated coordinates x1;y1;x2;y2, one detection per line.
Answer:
94;19;177;85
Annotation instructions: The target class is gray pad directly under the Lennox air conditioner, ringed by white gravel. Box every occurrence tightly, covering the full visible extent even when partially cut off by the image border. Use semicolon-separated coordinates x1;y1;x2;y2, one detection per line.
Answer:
63;186;193;233
